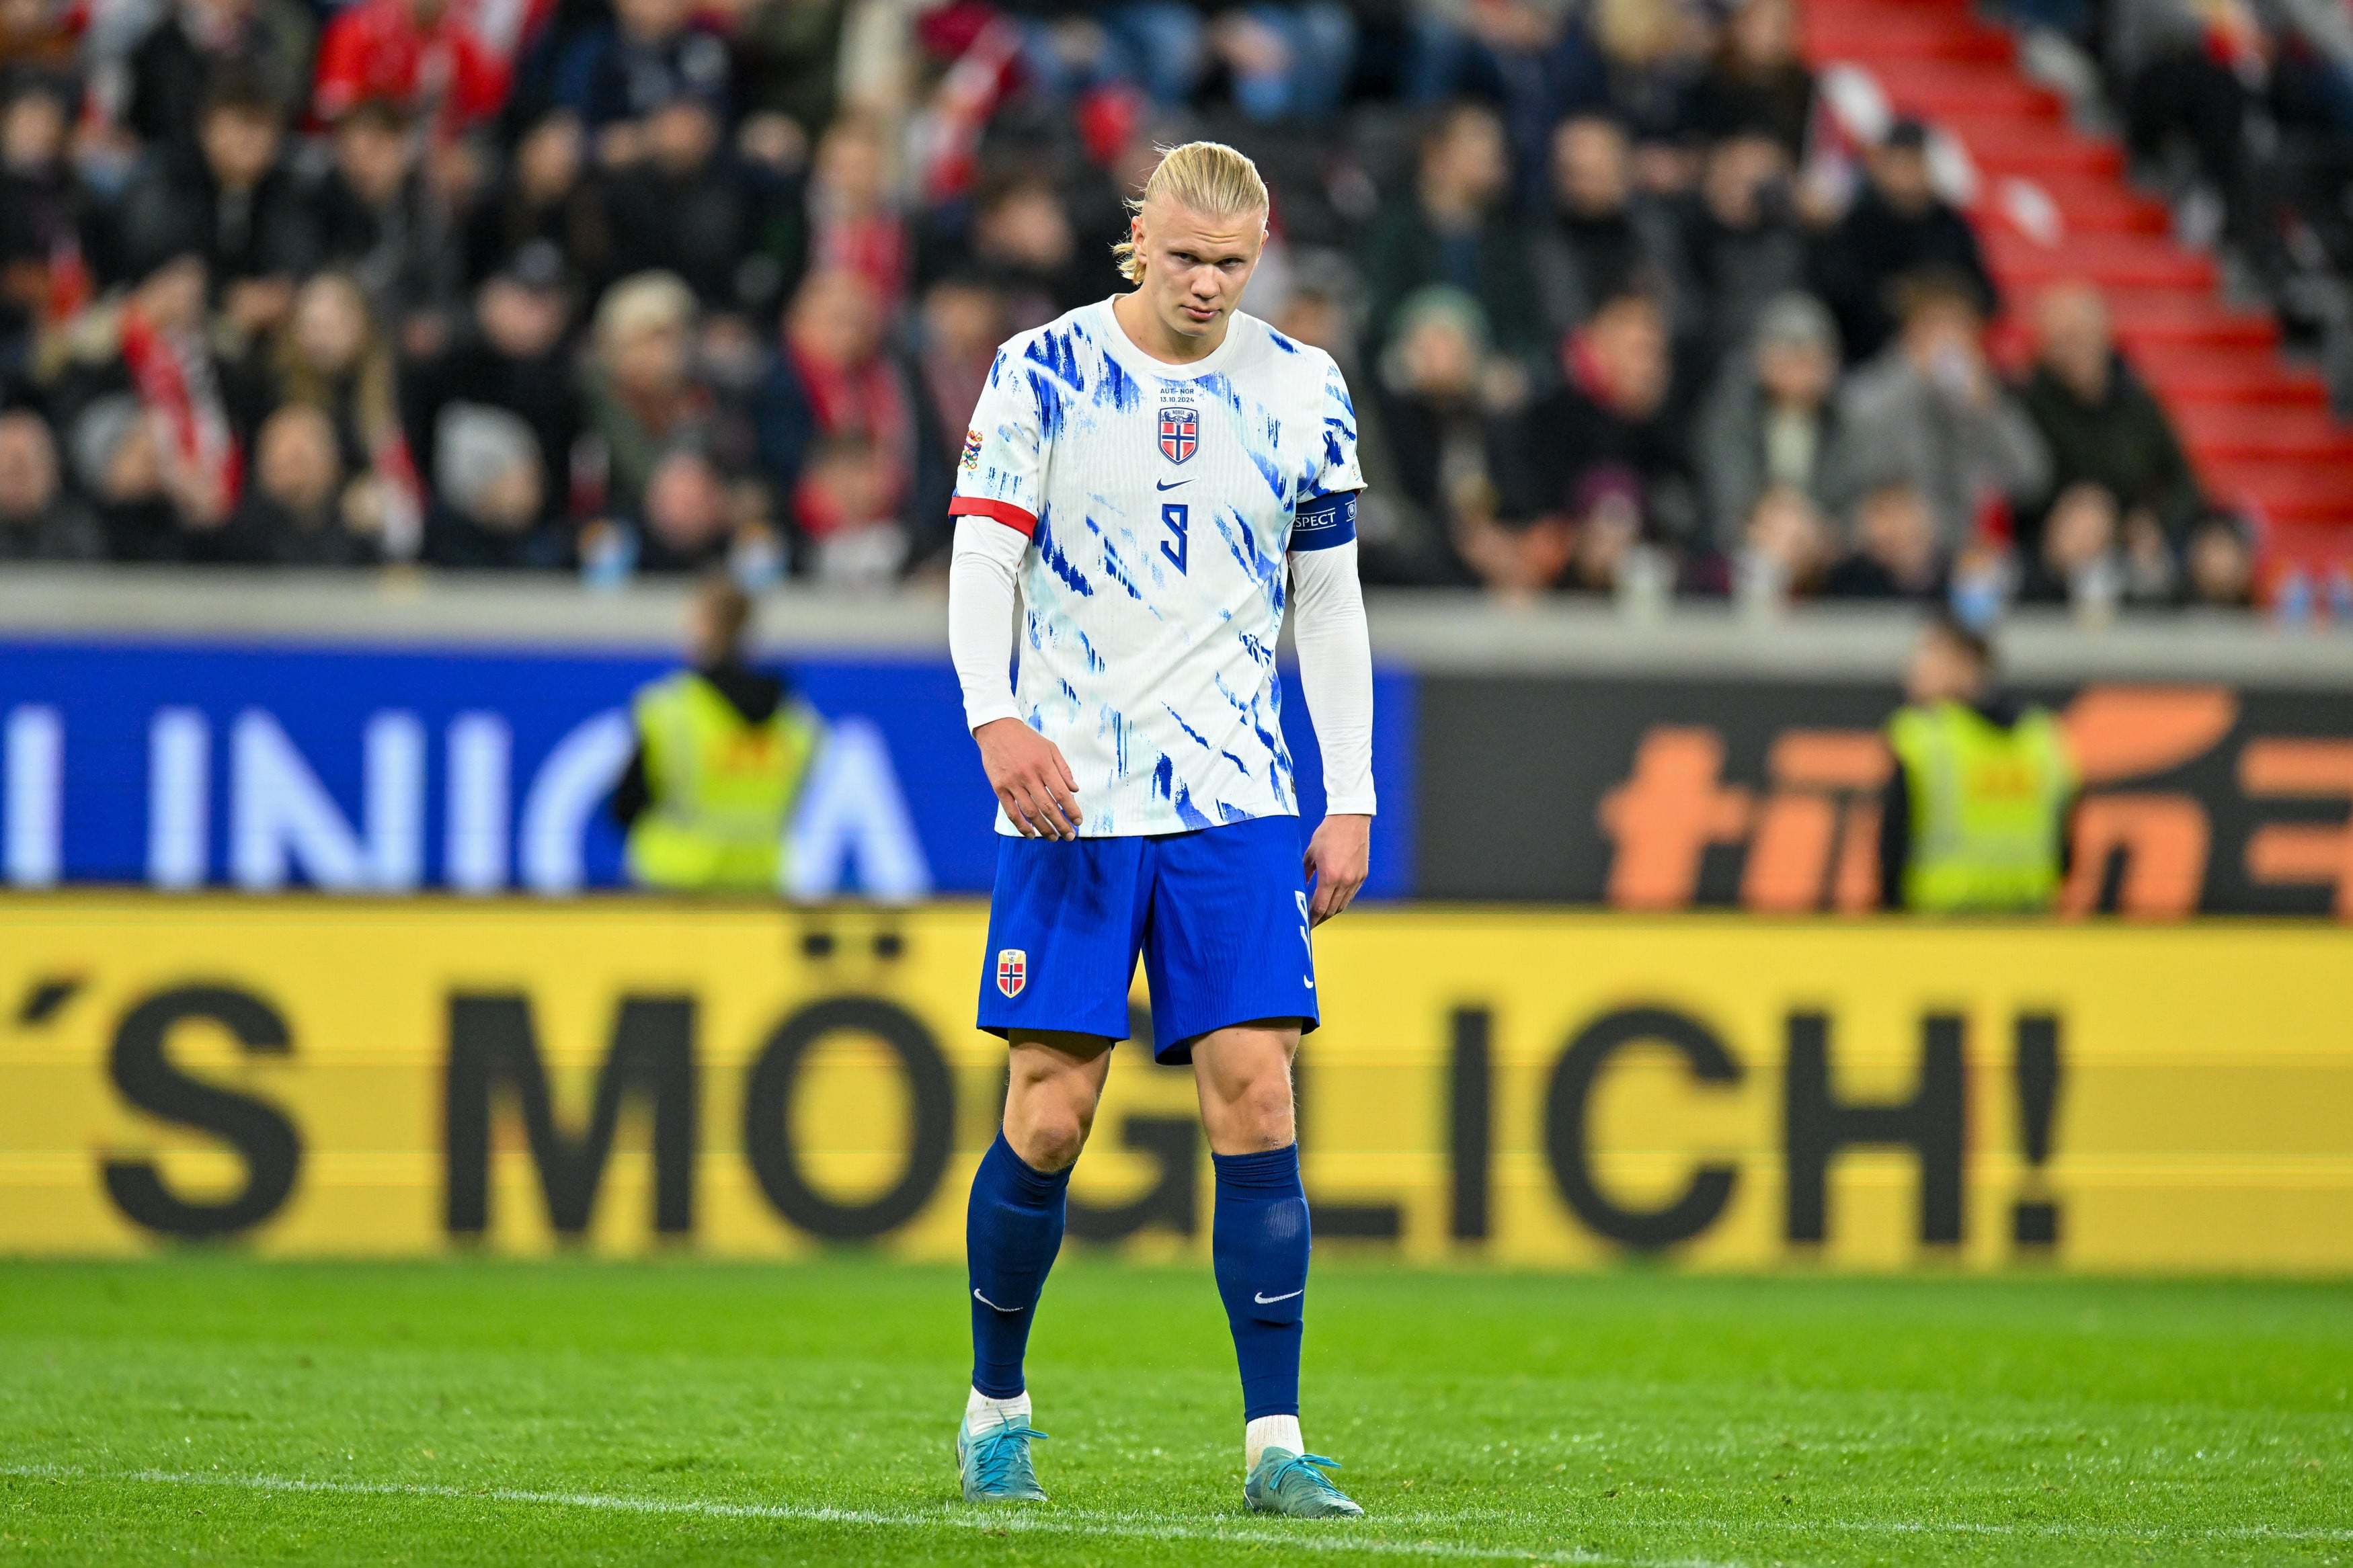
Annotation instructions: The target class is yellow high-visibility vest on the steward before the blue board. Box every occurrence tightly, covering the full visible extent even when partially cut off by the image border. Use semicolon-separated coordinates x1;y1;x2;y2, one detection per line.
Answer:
629;670;824;893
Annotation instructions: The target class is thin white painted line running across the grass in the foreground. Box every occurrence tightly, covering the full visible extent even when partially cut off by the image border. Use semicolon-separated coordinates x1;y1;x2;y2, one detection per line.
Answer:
0;1464;1744;1568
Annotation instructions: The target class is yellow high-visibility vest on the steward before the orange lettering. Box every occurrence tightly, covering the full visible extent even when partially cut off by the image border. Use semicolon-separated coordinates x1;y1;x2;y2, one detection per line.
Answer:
1887;703;2075;915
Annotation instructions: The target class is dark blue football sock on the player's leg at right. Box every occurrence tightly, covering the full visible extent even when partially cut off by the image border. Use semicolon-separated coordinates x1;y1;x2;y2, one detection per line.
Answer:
1209;1143;1308;1420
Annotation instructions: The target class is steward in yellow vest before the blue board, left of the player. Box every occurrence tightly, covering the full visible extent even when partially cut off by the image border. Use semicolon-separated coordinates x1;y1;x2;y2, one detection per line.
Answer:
612;578;824;893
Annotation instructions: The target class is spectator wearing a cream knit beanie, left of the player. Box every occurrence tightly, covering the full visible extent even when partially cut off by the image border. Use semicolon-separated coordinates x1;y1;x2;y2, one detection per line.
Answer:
584;273;713;518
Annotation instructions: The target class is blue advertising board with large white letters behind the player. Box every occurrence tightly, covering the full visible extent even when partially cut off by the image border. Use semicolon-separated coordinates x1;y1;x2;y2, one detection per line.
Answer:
0;639;1414;898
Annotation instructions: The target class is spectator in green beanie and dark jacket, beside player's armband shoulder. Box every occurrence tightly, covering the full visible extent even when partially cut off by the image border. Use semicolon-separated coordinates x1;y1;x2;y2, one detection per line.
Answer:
1355;284;1542;587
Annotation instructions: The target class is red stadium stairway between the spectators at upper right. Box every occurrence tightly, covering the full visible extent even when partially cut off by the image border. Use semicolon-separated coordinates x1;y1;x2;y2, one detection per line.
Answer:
1802;0;2353;583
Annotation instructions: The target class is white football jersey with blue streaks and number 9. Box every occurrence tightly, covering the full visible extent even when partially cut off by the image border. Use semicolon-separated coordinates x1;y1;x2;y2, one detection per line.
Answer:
949;301;1365;837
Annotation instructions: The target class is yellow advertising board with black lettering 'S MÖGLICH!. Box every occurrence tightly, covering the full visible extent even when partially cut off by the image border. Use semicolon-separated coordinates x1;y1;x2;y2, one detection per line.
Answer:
0;896;2353;1272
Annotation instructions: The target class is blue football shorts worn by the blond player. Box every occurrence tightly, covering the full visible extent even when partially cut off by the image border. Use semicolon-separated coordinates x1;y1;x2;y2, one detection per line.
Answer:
982;816;1318;1063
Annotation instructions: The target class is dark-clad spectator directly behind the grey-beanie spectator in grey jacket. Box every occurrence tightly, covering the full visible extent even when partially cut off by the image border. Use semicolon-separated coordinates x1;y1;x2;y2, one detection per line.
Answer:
1683;129;1805;362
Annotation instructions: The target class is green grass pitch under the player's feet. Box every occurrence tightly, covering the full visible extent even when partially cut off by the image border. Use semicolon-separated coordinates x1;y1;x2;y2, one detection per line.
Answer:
0;1255;2353;1566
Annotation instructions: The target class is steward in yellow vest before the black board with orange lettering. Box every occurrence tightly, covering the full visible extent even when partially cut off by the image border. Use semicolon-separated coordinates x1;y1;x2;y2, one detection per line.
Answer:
1880;620;2075;915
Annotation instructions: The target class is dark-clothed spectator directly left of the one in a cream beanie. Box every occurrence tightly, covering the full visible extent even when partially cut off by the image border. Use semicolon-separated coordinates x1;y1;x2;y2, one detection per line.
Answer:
403;242;582;522
